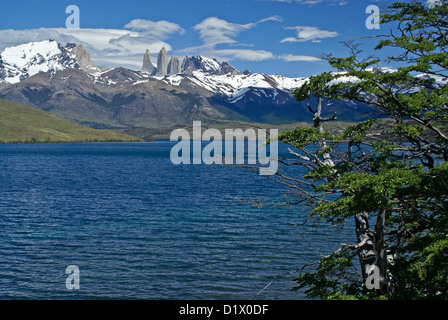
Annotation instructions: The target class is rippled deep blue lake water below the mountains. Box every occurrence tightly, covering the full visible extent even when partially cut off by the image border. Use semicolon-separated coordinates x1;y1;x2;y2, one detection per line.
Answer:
0;141;353;300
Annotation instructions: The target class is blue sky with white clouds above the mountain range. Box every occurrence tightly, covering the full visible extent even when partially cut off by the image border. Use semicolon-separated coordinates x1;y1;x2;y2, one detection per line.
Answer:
0;0;400;77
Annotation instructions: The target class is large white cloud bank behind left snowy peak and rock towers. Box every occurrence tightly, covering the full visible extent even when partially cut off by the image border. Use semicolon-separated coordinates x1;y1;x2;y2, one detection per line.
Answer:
0;19;185;69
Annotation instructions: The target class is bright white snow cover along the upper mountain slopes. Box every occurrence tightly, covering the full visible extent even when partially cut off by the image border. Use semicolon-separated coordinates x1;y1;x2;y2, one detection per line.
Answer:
4;40;448;112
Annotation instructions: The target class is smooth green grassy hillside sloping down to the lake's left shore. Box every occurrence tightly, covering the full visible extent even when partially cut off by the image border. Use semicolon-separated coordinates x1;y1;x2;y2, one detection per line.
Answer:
0;99;141;143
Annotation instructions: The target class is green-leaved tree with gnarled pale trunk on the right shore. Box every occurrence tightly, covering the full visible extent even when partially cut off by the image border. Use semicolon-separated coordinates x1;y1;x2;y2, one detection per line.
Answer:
272;1;448;299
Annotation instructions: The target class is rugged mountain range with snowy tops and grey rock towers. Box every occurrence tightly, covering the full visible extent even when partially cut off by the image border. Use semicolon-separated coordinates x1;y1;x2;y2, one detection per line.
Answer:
0;40;412;134
